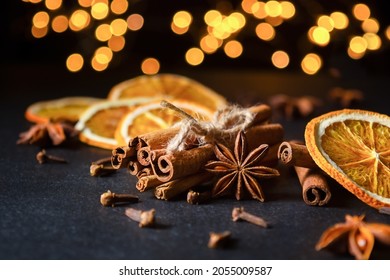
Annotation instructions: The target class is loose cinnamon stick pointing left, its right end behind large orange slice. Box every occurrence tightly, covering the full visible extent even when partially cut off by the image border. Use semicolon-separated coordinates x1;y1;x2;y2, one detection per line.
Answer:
278;141;318;168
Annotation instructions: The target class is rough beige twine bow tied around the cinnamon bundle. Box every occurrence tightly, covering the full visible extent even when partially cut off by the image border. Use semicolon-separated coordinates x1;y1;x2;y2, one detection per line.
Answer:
161;100;254;153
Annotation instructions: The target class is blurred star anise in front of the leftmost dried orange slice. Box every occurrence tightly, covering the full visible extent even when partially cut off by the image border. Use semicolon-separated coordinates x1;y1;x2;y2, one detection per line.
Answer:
16;122;78;147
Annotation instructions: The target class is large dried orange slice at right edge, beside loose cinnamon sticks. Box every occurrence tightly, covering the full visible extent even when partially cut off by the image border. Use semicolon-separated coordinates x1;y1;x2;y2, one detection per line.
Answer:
305;109;390;208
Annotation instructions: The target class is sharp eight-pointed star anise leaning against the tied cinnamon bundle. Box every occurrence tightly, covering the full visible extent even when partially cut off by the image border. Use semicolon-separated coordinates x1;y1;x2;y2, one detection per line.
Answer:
205;131;279;202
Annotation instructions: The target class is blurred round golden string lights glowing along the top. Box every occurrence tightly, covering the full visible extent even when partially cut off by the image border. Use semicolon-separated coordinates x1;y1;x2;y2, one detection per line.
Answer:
22;0;390;75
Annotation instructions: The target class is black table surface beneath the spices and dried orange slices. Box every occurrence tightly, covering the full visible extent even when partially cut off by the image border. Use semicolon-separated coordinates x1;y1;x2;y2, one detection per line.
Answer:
0;65;390;260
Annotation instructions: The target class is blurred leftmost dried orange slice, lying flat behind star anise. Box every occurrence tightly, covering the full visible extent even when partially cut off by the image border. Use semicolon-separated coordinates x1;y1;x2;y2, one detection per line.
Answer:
25;96;104;123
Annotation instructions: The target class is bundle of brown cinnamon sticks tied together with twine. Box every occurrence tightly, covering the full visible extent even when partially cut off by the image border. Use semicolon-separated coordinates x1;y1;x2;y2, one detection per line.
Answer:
111;104;284;200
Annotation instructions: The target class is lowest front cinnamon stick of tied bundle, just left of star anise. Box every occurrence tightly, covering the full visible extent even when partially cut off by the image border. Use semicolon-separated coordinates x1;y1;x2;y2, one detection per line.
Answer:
154;172;213;200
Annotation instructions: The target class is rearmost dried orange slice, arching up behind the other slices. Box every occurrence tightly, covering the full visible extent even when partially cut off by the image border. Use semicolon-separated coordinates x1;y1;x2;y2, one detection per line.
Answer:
107;73;226;111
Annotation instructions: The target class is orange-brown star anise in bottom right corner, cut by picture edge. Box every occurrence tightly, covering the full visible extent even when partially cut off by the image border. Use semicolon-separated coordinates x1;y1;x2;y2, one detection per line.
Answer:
316;215;390;260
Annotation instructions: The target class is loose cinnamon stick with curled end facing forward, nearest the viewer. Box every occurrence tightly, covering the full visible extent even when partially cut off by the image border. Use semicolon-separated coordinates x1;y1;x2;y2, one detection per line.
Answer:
294;166;331;206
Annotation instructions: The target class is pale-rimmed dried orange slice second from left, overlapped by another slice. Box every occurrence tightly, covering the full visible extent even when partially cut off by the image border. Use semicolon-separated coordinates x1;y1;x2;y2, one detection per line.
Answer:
75;98;150;149
